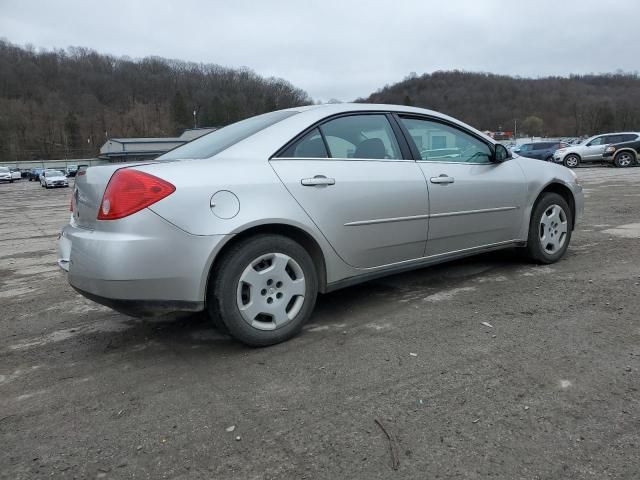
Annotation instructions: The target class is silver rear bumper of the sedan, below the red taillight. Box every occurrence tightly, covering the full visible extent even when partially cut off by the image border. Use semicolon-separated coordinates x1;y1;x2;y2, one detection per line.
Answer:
58;210;228;316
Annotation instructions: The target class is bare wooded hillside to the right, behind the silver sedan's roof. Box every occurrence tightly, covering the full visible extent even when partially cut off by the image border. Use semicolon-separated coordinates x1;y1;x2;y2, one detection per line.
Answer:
358;71;640;136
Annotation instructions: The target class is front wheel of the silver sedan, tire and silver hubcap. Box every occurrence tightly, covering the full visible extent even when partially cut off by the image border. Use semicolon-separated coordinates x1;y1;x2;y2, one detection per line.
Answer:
526;192;573;264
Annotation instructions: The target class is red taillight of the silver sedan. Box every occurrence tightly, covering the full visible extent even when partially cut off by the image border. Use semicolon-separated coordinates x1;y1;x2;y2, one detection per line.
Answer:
98;168;176;220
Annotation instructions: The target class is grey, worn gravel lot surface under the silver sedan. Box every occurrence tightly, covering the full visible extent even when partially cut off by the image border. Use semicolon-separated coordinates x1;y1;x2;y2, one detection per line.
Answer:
0;167;640;479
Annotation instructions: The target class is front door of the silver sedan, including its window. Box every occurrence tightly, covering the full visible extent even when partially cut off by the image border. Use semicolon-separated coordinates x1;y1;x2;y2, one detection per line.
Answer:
399;115;527;256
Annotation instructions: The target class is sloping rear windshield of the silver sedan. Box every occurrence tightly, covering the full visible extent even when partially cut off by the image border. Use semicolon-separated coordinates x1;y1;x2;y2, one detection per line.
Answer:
156;110;298;160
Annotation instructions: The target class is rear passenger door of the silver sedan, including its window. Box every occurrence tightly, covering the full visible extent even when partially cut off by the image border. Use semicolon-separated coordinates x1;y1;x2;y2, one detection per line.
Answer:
271;113;428;268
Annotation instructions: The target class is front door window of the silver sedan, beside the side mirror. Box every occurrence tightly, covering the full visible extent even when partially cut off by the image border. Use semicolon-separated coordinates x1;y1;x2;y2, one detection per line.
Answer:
401;118;492;163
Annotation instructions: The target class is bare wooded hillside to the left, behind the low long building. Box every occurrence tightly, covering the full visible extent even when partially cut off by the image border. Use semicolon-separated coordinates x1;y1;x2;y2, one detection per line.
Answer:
0;41;311;161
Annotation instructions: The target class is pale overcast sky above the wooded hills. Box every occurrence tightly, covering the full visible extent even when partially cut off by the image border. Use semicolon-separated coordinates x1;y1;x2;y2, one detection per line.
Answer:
0;0;640;101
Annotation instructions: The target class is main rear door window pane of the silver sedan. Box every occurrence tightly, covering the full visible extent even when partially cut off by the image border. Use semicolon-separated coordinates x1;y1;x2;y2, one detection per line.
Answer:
320;115;402;160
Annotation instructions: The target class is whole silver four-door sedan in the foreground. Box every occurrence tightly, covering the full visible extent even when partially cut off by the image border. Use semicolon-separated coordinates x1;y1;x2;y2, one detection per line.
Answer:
58;104;583;346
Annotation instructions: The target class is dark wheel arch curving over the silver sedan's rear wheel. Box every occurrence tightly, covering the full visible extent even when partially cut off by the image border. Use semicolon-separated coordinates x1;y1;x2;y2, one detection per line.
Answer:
205;223;327;297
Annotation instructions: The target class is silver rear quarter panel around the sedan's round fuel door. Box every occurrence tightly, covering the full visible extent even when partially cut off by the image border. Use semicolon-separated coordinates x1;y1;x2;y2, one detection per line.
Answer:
136;157;354;282
